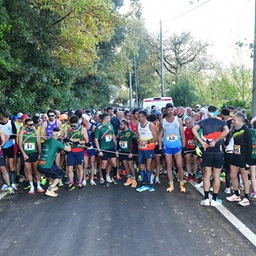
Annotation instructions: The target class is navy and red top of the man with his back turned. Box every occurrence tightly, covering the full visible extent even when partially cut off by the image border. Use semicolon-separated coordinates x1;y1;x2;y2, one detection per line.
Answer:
198;118;227;152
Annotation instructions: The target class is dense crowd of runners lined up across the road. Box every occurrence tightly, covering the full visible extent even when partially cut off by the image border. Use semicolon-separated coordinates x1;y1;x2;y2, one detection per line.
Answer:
0;103;256;206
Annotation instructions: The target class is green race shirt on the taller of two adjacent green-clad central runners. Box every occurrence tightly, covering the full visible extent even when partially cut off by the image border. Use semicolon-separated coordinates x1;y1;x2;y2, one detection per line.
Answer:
94;123;115;149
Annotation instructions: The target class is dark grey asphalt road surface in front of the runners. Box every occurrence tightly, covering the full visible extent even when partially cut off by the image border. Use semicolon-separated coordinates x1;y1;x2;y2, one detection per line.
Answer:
0;176;256;256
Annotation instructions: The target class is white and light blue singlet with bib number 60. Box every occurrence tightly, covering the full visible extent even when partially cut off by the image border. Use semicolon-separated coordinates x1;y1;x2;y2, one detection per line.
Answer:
163;116;182;148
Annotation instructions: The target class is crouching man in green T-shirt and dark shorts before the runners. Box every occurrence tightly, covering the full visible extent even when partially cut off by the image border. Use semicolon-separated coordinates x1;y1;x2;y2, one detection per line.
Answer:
38;127;71;197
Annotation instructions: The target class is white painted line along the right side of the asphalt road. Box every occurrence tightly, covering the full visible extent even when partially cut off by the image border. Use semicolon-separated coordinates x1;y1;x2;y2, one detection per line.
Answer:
190;182;256;246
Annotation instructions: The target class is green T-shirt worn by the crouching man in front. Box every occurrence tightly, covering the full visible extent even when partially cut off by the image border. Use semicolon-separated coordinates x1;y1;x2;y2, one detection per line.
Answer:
38;137;65;168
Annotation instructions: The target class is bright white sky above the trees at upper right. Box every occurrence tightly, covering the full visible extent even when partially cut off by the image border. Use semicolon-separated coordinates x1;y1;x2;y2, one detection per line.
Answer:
122;0;255;68
